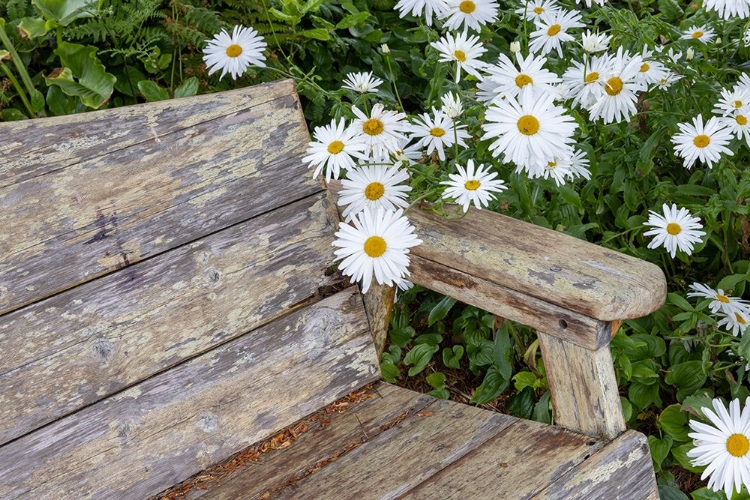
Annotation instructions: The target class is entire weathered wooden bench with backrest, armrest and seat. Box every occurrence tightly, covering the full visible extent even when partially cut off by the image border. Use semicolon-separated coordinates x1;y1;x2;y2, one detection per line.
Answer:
0;81;666;500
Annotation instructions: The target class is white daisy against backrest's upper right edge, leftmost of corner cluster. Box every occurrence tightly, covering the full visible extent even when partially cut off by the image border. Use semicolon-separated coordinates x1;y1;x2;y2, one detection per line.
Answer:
302;118;366;181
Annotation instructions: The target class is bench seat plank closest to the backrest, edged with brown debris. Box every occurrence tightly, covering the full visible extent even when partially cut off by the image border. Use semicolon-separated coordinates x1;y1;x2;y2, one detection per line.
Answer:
187;383;435;500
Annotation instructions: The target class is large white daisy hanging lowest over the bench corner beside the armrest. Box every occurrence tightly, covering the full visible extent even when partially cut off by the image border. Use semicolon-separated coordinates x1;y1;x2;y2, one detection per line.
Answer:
333;207;422;293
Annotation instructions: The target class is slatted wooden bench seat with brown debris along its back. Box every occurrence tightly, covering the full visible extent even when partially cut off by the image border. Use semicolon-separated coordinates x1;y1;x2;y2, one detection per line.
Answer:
160;382;658;500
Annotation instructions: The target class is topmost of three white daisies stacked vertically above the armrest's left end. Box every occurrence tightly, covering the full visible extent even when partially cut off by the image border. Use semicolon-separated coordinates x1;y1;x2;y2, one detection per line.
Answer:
351;103;409;161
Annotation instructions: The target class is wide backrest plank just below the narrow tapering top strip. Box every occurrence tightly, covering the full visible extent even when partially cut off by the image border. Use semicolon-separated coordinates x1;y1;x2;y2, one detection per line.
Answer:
0;84;320;314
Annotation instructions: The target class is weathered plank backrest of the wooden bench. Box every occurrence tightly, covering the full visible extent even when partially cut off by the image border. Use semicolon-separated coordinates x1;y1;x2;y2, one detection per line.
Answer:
0;81;379;498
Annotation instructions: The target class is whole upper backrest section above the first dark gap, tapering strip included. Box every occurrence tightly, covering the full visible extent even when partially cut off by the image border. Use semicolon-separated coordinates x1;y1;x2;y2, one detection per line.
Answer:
0;82;321;314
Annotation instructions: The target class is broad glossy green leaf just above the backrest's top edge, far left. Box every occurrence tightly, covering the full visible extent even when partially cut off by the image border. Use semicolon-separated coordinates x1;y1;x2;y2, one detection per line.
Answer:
45;42;117;109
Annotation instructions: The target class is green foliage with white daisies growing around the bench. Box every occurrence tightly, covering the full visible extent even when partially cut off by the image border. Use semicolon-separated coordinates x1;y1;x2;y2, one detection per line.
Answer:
0;0;750;499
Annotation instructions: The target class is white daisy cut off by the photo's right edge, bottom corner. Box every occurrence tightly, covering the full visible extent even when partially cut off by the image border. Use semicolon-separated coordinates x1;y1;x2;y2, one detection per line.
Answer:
687;398;750;498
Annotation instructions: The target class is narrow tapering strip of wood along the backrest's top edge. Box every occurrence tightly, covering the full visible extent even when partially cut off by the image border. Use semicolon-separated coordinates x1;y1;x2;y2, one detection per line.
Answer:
0;80;295;187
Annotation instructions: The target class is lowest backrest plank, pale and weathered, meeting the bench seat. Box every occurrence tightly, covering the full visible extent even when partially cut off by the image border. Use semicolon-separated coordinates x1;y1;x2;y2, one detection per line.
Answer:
0;288;379;499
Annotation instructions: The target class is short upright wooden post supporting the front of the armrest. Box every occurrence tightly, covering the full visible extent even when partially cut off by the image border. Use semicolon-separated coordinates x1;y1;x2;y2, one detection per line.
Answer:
537;332;626;439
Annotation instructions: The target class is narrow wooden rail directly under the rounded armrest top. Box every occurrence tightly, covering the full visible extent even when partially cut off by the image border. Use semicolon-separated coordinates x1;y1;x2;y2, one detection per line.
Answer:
409;255;610;349
